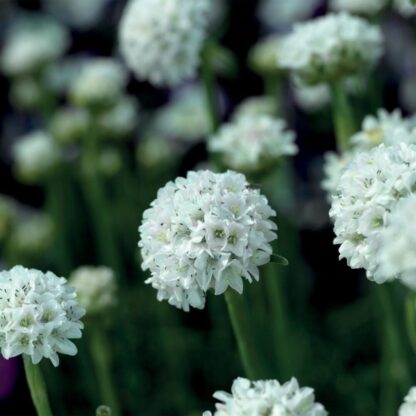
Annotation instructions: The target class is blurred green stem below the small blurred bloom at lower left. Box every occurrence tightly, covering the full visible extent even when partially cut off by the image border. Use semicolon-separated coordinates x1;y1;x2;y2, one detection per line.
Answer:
88;323;121;416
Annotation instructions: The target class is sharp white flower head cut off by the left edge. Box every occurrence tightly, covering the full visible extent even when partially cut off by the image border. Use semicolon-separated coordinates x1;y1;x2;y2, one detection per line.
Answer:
0;266;85;366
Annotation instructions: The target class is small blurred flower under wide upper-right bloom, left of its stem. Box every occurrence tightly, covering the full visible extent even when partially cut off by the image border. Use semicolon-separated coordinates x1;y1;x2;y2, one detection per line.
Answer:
292;80;331;113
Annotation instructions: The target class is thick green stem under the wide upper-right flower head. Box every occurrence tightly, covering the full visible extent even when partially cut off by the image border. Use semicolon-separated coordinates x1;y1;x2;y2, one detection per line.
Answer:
331;82;356;153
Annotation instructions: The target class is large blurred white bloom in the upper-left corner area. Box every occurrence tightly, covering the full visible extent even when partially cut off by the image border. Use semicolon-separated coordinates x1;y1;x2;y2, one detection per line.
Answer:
1;15;69;76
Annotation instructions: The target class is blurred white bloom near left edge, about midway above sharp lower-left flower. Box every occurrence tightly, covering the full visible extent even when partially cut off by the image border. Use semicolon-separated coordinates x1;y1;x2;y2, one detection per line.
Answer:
13;131;62;182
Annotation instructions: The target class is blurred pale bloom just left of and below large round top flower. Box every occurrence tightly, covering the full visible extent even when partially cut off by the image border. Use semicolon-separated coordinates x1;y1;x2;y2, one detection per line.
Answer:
70;58;127;108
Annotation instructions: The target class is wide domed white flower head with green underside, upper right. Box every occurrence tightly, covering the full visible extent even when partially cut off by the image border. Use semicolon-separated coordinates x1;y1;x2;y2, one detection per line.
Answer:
278;13;383;84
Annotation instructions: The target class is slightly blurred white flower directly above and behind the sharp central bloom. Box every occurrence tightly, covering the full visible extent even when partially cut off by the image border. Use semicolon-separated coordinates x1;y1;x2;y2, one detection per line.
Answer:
208;115;298;173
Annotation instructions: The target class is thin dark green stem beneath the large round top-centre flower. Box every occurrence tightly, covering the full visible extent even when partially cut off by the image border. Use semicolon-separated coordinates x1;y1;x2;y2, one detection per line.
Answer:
201;42;220;133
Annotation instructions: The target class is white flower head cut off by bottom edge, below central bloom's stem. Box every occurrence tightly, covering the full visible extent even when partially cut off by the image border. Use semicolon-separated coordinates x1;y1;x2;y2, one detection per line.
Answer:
203;378;328;416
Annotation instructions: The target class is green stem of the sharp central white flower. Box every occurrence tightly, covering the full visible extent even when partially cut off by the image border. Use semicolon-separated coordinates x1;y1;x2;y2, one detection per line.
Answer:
224;289;264;380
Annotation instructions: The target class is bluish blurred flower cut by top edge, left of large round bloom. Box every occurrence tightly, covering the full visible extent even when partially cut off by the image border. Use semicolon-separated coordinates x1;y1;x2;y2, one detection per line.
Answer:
43;0;109;29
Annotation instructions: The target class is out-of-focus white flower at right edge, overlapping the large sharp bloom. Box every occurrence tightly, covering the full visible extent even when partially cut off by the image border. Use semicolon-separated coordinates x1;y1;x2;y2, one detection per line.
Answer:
378;194;416;289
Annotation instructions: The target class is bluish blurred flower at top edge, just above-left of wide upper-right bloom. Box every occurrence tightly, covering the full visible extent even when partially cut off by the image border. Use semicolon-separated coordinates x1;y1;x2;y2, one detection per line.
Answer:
258;0;320;29
